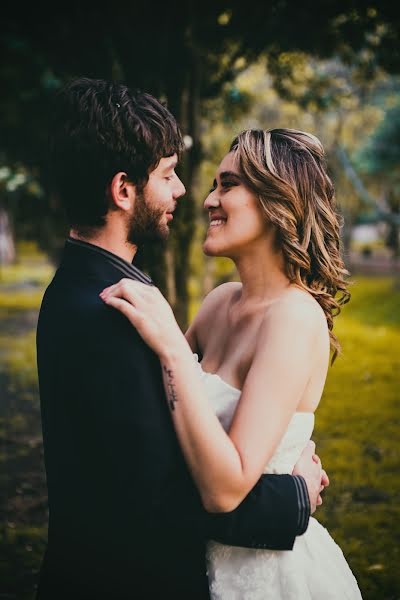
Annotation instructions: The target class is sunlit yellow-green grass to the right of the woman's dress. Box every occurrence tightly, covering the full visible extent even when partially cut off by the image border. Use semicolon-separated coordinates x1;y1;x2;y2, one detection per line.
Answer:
314;277;400;600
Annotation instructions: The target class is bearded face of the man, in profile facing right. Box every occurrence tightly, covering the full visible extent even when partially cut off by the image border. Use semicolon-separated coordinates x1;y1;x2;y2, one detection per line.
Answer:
127;154;186;245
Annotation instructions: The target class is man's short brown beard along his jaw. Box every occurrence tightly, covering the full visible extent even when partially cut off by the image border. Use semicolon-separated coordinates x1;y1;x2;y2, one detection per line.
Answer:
127;191;169;246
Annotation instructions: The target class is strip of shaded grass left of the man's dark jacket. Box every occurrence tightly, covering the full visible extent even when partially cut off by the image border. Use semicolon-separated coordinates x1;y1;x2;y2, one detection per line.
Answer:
0;244;54;600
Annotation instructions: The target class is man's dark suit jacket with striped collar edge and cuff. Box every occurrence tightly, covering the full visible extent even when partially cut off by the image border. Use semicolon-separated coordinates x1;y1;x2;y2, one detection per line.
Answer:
37;241;309;600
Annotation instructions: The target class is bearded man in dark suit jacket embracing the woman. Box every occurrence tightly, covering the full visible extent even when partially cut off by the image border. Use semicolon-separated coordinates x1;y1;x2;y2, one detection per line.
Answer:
37;78;324;600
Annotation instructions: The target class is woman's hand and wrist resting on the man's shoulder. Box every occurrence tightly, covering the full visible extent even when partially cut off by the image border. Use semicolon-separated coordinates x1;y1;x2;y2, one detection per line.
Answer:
100;279;187;358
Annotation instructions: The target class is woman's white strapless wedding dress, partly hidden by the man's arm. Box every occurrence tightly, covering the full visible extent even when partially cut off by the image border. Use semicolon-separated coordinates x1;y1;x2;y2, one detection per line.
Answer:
194;354;361;600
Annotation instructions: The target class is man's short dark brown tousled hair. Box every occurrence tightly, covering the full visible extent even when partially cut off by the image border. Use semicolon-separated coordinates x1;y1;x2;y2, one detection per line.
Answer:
46;77;184;231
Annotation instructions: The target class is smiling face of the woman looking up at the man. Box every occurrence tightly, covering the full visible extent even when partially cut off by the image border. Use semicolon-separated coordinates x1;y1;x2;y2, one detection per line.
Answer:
203;152;266;259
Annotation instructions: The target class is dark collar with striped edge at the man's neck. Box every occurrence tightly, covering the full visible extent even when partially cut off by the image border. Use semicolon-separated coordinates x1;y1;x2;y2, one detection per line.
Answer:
60;237;153;285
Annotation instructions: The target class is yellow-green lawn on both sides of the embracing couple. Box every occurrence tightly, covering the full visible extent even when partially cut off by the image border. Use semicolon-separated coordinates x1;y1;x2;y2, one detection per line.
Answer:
0;254;400;600
